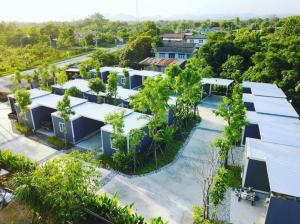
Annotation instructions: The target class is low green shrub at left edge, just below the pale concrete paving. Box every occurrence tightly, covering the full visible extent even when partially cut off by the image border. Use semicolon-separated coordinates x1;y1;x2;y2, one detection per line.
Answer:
0;150;37;173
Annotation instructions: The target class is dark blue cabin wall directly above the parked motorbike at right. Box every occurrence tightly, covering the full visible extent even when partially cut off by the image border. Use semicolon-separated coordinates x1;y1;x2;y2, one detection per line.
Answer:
244;159;270;192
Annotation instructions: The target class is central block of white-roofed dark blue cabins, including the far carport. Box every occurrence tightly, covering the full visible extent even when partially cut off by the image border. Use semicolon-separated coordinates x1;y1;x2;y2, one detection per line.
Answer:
8;67;232;155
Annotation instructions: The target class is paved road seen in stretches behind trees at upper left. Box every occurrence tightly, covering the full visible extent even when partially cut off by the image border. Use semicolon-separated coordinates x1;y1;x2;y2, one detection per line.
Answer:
0;46;124;92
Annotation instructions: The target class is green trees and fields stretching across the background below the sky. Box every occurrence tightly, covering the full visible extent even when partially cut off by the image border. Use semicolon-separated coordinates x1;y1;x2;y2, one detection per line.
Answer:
0;14;300;111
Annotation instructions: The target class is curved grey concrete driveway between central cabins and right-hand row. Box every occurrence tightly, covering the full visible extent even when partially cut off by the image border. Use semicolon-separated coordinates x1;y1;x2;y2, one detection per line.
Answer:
100;103;224;224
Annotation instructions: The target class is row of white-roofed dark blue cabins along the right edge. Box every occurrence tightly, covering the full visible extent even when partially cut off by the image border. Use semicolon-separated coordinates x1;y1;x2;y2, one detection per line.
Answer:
242;82;300;224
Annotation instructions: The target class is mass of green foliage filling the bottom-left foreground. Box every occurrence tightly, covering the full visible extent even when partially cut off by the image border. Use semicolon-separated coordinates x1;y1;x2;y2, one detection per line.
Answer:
0;150;165;224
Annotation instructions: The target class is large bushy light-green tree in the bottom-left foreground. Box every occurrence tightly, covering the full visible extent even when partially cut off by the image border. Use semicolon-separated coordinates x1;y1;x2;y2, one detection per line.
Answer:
13;151;101;224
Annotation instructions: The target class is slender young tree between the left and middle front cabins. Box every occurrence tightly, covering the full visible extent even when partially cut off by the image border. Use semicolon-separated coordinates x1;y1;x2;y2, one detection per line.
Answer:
56;92;74;145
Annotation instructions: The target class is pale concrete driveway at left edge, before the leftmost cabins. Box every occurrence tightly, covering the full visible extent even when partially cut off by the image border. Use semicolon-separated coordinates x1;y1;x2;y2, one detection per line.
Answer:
0;103;58;162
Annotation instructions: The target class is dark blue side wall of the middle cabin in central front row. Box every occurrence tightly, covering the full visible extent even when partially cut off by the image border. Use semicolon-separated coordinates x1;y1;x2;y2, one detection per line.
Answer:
73;117;104;142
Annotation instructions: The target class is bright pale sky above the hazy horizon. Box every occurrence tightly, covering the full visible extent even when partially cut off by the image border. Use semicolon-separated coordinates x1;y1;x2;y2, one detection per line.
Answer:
0;0;300;22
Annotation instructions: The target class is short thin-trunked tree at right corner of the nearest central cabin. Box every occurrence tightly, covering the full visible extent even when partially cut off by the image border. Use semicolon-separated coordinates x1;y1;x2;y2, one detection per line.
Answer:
128;129;146;173
